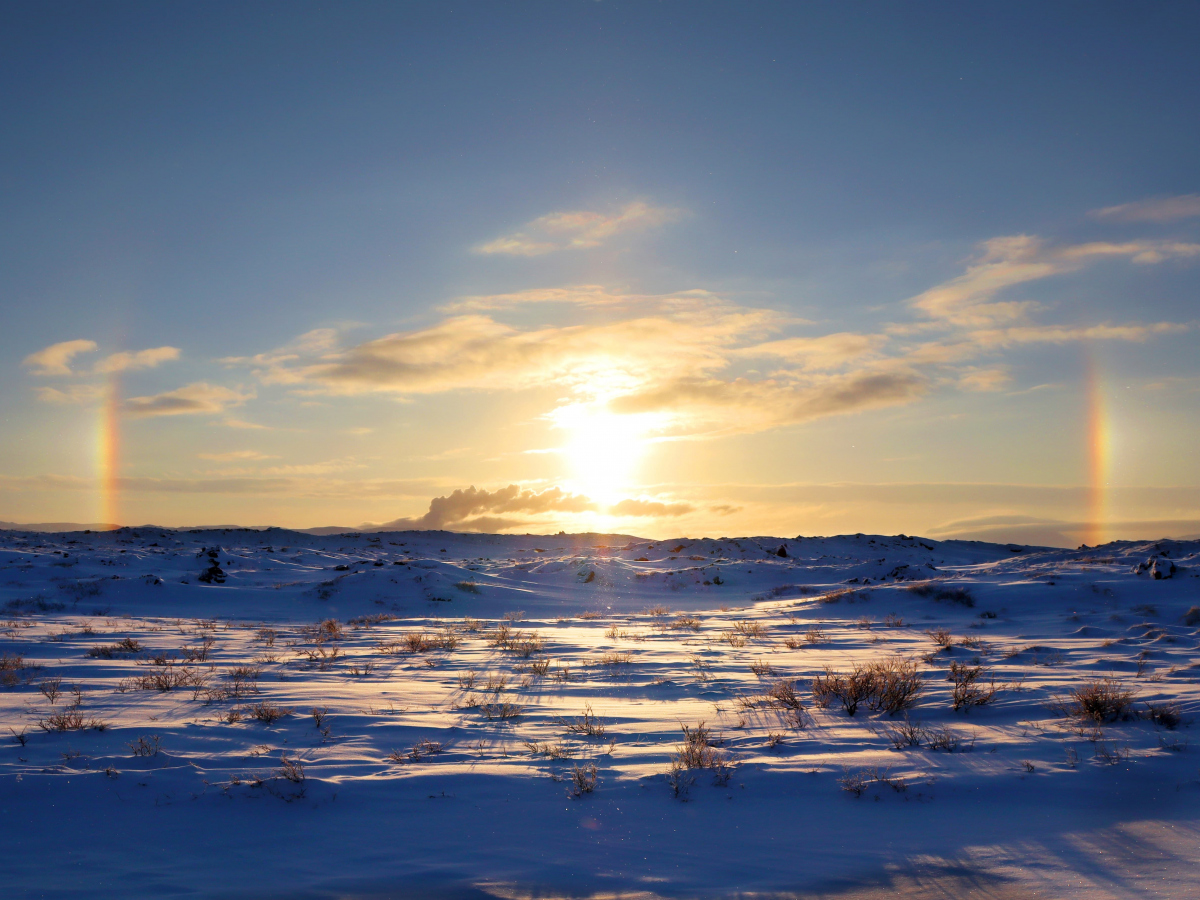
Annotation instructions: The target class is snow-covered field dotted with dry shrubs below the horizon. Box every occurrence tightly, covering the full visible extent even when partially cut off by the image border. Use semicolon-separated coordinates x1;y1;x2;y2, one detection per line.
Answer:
0;528;1200;898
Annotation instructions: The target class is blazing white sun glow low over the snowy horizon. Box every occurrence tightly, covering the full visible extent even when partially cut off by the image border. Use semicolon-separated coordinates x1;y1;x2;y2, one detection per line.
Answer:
554;404;653;506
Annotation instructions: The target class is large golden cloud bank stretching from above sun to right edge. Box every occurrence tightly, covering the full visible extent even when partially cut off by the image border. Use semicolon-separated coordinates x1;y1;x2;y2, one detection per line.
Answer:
229;225;1200;437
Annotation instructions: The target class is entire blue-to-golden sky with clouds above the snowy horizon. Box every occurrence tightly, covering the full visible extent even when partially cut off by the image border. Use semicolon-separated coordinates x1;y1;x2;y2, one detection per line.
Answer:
0;2;1200;541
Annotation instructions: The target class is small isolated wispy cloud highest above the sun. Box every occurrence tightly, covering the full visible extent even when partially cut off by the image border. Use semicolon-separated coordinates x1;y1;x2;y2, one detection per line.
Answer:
475;200;680;257
